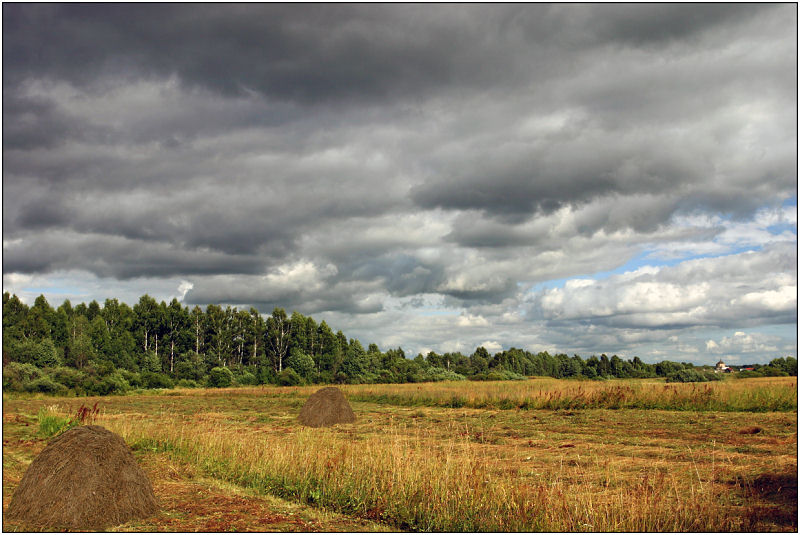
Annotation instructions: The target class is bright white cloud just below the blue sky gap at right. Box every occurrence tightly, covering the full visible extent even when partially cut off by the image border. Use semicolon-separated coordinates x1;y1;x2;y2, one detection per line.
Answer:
532;242;797;328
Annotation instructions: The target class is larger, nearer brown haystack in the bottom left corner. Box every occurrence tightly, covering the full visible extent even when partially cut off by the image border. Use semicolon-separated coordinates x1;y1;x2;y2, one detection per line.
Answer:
7;425;158;531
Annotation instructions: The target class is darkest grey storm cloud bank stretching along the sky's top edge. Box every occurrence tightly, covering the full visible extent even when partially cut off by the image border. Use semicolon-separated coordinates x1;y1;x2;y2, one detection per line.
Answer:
3;4;767;102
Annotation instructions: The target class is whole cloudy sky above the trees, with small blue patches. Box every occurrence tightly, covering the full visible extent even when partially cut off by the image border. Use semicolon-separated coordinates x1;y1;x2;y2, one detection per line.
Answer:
2;3;798;364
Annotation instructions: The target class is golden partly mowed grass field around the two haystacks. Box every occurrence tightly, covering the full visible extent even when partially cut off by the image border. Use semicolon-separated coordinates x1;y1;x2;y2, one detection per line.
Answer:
3;377;798;531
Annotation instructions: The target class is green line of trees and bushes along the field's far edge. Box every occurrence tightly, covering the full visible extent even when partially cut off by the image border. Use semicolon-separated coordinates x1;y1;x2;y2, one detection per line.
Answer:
3;292;797;395
